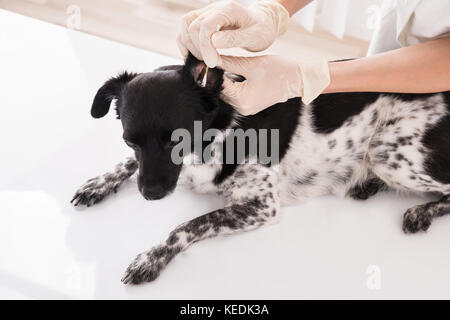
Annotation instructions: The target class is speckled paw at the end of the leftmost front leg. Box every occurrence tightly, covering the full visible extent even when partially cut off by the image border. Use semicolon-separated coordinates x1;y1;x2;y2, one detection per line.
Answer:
70;176;118;207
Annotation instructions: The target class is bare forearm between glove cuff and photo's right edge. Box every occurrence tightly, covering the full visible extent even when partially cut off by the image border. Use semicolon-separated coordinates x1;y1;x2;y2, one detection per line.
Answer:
324;37;450;93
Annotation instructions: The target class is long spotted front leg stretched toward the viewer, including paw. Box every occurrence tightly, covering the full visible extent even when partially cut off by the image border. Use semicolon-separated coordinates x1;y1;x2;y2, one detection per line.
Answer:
122;191;279;284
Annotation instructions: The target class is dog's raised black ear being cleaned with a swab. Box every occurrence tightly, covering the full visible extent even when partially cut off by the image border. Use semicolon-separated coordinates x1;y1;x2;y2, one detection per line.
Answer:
184;53;224;93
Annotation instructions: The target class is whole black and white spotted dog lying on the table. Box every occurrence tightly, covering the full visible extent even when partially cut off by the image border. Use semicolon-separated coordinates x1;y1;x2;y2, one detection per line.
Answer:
72;56;450;284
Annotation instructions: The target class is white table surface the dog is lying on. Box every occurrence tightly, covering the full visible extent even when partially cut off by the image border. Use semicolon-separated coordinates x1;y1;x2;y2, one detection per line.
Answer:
0;10;450;299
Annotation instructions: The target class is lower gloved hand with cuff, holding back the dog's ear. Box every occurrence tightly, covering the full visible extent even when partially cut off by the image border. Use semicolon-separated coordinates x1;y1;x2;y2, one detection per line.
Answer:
219;55;330;115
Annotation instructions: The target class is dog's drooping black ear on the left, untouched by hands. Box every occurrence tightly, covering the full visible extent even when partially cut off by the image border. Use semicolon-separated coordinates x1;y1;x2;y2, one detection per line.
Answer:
91;71;138;118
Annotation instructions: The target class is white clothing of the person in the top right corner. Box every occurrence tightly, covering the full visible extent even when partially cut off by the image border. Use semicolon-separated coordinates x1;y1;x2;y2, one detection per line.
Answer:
367;0;450;55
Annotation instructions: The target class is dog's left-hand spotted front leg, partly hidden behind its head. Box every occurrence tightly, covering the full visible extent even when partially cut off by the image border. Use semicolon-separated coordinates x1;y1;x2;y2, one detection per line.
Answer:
70;158;138;207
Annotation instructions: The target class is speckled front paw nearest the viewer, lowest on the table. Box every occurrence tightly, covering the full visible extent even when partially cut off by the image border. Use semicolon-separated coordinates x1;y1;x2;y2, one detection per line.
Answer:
122;245;180;284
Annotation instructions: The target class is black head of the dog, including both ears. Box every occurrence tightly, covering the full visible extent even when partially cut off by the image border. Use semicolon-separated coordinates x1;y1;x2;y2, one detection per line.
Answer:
91;55;231;200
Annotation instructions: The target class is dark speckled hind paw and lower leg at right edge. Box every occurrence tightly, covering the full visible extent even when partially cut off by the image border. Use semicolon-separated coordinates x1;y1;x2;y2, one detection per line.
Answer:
403;195;450;233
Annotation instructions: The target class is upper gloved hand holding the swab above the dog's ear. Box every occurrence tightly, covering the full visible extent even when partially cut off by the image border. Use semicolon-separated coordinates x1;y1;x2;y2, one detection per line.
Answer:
177;0;289;68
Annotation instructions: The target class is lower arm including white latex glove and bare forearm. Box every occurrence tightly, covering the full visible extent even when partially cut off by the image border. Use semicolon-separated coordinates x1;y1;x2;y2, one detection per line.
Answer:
220;37;450;115
